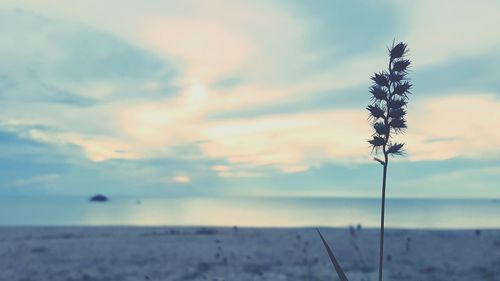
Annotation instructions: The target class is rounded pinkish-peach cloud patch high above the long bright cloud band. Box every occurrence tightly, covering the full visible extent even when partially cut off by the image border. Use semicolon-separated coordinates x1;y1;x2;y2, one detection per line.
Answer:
141;18;253;81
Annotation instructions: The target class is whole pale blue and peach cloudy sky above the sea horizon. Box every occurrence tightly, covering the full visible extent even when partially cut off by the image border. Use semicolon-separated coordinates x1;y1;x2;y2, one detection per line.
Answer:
0;0;500;198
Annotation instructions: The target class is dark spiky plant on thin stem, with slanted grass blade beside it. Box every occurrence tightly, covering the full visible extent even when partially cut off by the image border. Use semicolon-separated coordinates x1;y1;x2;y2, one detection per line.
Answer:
318;42;412;281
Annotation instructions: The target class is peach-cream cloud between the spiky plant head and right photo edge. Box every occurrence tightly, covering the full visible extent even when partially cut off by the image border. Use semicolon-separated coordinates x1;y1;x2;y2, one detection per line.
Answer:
404;92;500;160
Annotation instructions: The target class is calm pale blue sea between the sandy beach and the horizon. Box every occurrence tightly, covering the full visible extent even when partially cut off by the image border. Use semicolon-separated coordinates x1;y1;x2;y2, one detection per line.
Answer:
0;197;500;228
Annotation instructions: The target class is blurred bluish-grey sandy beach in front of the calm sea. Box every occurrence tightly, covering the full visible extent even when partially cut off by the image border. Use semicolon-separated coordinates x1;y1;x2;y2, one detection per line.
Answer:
0;226;500;281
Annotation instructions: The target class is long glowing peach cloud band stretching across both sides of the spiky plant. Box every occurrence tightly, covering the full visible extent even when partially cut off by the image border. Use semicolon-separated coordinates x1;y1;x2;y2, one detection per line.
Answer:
9;82;500;173
